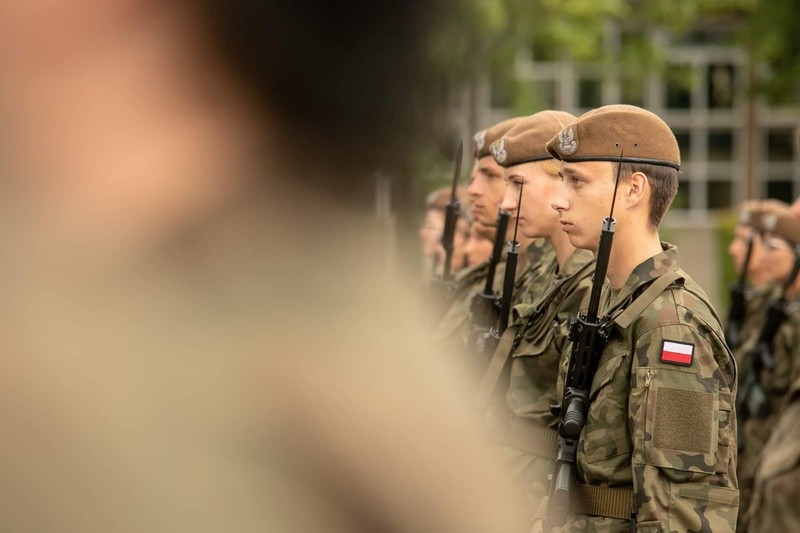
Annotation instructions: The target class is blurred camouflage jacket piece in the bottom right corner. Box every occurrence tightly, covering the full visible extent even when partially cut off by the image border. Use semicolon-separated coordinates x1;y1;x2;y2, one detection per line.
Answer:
745;372;800;533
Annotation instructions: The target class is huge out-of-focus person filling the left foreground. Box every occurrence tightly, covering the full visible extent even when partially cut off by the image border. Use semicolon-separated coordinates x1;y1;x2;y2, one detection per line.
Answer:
0;0;506;533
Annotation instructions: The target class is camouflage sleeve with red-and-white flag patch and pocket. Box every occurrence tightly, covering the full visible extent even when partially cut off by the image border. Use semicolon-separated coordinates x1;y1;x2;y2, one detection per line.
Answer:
628;324;739;531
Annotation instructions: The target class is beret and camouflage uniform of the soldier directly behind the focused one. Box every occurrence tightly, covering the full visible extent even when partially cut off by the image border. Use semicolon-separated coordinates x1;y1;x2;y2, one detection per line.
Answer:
479;111;594;532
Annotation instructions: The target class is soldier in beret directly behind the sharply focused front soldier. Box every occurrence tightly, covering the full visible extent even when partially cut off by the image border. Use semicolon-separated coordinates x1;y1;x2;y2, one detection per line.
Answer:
472;111;594;532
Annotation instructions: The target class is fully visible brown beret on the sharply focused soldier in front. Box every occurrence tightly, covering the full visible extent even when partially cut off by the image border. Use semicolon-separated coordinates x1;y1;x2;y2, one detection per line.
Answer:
547;104;681;170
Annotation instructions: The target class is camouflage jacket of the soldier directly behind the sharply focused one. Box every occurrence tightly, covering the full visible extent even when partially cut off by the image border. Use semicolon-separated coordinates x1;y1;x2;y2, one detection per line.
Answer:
498;250;594;532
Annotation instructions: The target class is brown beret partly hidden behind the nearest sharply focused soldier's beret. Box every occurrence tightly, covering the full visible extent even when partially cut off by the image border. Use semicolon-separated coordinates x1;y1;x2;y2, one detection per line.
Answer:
492;110;577;167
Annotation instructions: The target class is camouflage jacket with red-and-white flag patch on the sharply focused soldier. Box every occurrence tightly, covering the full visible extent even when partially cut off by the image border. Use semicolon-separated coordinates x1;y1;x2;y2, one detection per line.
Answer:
540;243;738;531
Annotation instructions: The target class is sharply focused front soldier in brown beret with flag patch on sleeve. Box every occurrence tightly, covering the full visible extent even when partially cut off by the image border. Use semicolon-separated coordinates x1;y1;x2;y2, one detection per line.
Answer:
537;105;738;531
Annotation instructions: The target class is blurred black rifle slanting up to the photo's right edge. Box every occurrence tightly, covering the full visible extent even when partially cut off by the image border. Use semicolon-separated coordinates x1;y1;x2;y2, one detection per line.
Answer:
736;245;800;450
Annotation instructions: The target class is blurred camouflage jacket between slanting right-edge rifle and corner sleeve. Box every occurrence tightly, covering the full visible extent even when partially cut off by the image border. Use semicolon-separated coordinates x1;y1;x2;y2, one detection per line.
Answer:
737;297;800;531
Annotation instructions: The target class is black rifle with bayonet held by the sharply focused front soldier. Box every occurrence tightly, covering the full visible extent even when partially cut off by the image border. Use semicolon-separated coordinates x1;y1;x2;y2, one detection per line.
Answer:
544;153;622;531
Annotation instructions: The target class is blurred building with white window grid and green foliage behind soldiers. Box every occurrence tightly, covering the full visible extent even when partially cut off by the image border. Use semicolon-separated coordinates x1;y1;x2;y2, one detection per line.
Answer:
390;0;800;310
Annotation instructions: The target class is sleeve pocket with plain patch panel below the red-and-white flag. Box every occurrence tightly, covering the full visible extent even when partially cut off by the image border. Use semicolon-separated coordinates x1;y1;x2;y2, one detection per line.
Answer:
631;367;720;483
